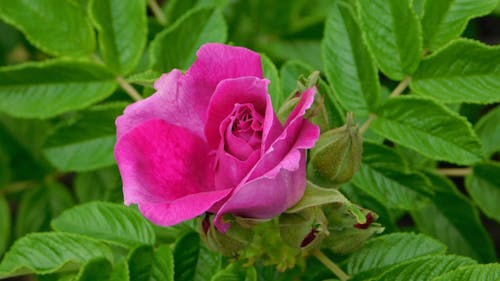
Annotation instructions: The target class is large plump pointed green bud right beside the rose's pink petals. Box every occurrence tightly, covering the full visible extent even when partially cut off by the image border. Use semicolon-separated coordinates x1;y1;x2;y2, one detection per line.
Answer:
308;114;363;187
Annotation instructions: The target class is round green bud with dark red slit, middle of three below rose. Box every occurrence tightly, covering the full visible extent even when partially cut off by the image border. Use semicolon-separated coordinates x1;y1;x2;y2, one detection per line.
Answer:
279;207;328;250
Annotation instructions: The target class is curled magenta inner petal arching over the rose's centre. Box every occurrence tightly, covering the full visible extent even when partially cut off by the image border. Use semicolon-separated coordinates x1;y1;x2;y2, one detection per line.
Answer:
205;77;269;149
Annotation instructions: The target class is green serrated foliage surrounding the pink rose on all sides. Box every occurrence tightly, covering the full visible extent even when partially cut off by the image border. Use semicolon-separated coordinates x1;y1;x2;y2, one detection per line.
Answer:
0;0;500;281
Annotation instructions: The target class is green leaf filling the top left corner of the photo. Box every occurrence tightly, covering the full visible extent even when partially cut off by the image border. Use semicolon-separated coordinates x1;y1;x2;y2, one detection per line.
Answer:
0;0;95;56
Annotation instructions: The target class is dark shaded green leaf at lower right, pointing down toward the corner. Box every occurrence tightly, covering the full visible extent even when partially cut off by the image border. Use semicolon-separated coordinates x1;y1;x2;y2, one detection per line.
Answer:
411;173;495;262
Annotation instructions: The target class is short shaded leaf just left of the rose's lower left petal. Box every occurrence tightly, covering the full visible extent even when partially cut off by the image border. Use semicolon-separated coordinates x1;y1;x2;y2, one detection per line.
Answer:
74;166;123;203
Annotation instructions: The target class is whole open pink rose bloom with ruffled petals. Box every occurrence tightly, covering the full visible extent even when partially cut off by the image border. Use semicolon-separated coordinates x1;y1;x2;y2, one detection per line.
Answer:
115;44;319;231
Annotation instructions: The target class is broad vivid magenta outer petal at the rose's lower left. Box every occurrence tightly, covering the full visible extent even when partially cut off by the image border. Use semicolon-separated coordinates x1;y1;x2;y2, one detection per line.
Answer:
115;119;227;224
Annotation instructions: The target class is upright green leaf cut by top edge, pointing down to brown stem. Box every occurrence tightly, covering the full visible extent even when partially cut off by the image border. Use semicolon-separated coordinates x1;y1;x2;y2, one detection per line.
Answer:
89;0;147;74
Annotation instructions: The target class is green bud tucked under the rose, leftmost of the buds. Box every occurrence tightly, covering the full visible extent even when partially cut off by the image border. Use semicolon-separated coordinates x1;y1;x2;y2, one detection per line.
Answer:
198;214;253;256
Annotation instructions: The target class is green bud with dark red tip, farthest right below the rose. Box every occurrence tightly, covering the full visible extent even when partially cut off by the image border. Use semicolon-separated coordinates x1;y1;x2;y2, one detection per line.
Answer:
323;201;384;254
